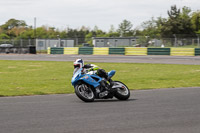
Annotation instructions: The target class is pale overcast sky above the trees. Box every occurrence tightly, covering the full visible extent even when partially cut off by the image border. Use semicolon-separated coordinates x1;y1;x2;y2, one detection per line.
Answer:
0;0;200;31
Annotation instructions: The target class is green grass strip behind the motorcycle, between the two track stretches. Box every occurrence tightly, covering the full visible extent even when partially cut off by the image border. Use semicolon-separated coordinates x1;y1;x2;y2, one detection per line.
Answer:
0;60;200;96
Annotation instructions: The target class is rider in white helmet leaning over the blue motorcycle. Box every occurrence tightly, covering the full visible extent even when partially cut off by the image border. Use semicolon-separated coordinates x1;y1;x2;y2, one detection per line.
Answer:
74;59;112;94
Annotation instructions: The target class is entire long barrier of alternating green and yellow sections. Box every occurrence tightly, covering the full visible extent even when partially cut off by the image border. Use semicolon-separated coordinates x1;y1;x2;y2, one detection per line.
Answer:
48;47;200;56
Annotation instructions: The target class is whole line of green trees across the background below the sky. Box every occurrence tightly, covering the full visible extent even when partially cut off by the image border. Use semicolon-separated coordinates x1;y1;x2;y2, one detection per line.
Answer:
0;5;200;43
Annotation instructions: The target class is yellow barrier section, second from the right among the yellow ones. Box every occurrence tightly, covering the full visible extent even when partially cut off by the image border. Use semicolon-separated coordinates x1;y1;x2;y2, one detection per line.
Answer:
125;47;147;55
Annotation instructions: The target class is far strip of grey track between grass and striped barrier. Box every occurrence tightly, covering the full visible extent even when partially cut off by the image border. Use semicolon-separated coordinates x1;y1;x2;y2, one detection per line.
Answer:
0;54;200;65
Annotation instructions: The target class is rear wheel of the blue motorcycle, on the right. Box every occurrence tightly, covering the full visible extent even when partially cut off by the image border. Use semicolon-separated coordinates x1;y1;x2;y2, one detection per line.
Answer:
112;81;130;100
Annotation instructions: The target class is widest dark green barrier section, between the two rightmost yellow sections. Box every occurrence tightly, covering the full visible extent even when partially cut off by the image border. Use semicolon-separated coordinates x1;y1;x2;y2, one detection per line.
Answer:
147;48;170;55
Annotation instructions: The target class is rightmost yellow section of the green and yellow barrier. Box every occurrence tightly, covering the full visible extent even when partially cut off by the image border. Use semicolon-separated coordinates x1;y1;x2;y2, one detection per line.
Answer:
170;48;195;56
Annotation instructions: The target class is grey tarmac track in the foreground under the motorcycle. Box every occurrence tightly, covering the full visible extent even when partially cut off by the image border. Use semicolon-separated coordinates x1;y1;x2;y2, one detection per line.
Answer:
0;88;200;133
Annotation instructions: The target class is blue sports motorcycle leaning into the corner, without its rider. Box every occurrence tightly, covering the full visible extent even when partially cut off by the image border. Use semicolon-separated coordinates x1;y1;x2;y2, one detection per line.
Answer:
71;68;130;102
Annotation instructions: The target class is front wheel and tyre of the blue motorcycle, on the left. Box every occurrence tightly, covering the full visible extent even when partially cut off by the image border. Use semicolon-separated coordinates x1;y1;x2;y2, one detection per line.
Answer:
75;83;95;102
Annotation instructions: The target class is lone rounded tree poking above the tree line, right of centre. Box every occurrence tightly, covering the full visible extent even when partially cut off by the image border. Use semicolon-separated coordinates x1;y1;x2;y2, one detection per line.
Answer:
118;19;133;37
